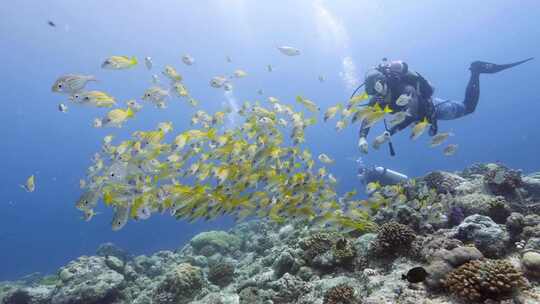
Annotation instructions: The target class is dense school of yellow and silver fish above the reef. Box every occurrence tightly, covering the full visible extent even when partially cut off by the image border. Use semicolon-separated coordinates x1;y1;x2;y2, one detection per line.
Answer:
45;50;379;230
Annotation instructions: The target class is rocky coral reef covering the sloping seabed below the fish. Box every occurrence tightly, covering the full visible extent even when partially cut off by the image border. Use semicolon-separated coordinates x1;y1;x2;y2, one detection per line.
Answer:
0;164;540;304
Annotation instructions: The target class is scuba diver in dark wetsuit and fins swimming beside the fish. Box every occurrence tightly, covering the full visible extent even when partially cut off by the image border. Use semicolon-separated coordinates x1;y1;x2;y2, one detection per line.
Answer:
353;58;534;156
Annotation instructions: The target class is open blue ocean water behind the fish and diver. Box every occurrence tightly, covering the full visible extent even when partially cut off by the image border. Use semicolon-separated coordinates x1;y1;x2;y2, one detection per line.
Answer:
0;0;540;280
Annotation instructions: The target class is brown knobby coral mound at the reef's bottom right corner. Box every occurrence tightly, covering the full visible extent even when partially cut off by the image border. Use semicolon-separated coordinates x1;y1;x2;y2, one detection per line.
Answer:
445;260;526;303
